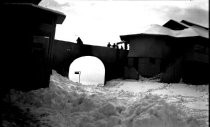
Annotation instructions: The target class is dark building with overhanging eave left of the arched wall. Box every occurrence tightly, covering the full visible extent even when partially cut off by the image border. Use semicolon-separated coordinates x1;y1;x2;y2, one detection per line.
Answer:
0;0;65;91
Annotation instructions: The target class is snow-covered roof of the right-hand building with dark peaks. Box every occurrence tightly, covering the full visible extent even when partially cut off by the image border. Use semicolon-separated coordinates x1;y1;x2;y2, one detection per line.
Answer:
120;20;209;41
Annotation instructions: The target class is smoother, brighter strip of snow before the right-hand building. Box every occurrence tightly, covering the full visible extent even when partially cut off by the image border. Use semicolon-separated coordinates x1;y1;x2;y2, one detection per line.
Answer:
108;80;209;124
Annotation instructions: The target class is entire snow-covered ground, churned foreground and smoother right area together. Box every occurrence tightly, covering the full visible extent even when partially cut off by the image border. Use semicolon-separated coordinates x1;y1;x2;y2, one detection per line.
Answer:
1;71;209;127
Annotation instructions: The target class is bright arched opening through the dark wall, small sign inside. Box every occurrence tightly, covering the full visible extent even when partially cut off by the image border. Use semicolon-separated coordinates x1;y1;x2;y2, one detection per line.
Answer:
69;56;105;85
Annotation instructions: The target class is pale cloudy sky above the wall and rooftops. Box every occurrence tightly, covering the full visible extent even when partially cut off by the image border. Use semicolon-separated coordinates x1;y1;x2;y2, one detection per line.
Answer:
40;0;209;46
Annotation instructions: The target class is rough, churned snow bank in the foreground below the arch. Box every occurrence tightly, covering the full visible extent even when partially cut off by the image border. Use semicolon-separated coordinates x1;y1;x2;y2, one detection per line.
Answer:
2;72;206;127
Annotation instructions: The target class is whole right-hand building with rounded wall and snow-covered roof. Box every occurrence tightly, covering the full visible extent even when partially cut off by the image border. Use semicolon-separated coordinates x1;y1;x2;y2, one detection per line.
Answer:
120;20;209;84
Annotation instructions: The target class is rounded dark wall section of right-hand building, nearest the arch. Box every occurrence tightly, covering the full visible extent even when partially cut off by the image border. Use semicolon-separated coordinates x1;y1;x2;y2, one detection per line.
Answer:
121;31;172;79
